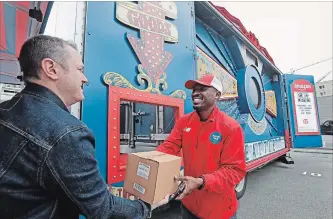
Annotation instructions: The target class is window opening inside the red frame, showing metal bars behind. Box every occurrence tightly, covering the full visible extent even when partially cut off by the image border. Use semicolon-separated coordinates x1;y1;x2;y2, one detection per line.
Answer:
120;101;175;154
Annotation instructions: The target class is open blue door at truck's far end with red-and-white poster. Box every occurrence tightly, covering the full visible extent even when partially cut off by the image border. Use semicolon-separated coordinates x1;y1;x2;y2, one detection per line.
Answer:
283;74;323;148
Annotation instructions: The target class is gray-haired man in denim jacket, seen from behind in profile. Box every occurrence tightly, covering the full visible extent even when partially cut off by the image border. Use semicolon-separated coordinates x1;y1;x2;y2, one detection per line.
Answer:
0;35;168;219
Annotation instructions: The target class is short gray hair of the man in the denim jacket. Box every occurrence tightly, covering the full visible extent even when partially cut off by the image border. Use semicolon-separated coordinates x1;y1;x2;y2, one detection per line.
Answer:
18;35;77;82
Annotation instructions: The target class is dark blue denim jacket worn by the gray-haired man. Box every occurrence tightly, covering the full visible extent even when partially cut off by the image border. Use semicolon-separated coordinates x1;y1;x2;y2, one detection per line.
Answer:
0;83;150;219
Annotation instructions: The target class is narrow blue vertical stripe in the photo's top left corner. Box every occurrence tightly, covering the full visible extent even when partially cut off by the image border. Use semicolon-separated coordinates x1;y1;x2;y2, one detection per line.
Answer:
3;4;16;55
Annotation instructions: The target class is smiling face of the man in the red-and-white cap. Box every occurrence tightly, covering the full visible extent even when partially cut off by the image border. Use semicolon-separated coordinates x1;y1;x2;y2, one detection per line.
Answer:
192;84;221;111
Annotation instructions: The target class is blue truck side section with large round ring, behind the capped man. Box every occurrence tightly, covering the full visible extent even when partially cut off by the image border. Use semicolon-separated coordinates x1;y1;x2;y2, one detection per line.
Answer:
195;3;286;163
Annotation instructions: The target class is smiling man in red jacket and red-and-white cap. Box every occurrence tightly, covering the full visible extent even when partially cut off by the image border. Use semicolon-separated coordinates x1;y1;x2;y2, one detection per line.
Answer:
157;74;246;219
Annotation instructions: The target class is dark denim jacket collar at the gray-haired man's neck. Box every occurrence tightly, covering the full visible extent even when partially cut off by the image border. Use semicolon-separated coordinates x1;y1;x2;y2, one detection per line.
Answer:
22;83;69;112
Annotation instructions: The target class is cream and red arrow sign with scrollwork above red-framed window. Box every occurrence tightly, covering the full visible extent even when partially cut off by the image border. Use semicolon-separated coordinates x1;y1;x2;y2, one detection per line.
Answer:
104;1;186;99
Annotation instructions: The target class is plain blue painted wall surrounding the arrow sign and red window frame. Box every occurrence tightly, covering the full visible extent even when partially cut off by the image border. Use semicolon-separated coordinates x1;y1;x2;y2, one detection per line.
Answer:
82;2;196;179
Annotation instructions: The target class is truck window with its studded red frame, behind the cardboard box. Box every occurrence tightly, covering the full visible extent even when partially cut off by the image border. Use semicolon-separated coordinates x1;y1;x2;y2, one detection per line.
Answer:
107;86;184;183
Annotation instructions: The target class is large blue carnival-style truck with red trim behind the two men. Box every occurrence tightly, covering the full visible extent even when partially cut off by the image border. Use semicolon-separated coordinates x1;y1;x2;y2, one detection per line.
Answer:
0;1;322;212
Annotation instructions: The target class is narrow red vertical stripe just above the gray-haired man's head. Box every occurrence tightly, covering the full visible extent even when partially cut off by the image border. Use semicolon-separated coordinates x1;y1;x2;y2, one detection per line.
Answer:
15;9;28;57
